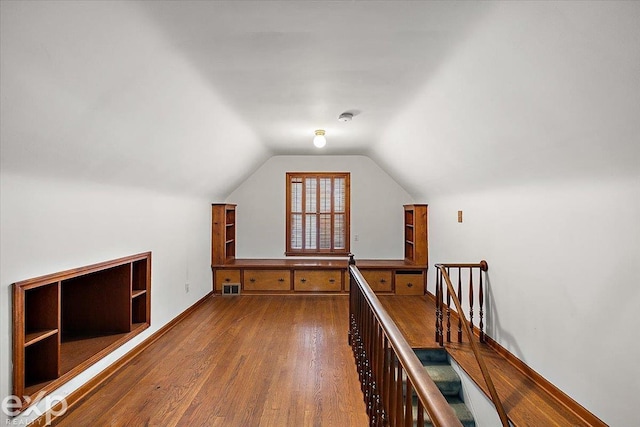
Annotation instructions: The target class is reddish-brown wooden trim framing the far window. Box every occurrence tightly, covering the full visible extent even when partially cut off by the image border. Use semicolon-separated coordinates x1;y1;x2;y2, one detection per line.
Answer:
285;172;351;256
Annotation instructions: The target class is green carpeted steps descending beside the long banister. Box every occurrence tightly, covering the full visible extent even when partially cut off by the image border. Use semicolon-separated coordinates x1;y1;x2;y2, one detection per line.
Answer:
413;349;476;427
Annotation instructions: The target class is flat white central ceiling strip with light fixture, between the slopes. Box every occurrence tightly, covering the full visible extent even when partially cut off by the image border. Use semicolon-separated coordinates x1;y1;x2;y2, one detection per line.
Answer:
132;1;490;154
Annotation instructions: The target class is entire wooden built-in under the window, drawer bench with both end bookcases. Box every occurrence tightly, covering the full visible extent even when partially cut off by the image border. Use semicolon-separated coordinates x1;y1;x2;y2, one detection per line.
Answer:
211;203;428;295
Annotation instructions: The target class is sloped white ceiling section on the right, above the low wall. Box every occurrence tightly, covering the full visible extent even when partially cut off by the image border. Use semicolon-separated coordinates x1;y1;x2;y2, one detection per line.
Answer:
371;1;640;198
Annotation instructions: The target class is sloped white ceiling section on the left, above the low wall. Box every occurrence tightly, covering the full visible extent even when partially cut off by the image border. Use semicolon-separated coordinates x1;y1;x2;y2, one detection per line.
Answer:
0;1;269;197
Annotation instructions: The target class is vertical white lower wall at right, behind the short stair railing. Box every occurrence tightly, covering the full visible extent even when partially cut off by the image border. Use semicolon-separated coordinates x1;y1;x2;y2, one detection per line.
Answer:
429;177;640;426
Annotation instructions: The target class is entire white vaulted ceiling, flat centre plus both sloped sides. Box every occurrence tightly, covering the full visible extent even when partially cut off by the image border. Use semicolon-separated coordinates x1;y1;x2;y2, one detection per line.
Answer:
0;1;640;199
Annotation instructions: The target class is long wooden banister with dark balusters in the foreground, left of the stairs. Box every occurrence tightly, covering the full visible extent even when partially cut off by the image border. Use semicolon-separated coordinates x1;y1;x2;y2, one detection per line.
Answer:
349;265;461;427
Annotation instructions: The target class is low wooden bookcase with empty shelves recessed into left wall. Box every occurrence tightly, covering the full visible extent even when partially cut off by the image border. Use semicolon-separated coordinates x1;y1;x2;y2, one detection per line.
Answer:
13;252;151;409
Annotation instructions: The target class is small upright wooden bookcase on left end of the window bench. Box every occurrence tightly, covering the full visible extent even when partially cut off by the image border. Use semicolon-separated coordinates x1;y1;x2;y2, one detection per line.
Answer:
211;203;236;265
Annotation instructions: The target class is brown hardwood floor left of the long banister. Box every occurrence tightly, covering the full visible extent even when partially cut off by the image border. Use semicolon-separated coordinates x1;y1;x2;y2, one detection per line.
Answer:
57;295;368;427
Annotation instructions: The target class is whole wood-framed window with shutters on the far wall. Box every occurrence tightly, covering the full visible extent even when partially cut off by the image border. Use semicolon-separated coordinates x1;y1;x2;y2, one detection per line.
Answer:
286;172;350;255
